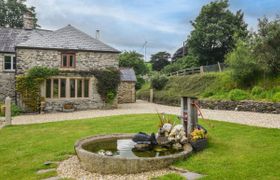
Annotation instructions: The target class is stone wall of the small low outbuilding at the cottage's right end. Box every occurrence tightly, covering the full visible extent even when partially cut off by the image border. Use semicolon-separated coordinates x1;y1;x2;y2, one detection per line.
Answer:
118;81;135;104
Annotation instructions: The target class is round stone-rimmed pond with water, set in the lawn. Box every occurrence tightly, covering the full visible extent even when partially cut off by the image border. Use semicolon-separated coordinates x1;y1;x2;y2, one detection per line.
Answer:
75;134;192;174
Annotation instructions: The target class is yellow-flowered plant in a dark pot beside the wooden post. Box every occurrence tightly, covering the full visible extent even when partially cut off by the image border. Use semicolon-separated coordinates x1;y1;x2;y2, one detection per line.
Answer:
190;128;207;151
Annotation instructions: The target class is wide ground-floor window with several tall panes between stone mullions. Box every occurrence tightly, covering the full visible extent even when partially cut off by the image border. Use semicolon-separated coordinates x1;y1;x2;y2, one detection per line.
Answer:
46;78;90;99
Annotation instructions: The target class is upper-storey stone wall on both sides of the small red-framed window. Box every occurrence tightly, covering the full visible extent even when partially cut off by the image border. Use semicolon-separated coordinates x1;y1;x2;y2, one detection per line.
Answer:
17;48;119;73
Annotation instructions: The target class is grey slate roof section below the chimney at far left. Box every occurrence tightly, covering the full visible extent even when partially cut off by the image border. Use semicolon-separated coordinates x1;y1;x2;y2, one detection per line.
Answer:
0;27;52;53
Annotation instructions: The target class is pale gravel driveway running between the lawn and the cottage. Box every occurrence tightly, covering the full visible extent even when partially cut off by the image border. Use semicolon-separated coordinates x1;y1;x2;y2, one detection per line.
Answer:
12;100;280;128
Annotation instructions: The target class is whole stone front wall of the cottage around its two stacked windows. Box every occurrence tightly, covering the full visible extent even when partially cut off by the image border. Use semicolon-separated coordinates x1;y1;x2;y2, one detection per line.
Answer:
17;49;118;112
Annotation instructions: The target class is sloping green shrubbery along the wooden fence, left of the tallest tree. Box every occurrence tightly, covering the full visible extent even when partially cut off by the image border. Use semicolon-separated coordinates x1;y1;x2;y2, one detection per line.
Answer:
162;54;199;73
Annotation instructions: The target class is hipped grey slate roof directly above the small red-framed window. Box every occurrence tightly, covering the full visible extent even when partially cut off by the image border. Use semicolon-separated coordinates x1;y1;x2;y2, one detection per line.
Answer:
17;25;119;53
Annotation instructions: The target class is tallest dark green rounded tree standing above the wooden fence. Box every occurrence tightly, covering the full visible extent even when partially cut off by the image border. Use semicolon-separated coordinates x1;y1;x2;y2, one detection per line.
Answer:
187;0;248;65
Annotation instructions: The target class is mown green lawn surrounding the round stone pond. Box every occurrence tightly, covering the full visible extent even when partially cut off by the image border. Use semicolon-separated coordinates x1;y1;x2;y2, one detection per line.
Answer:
0;115;280;180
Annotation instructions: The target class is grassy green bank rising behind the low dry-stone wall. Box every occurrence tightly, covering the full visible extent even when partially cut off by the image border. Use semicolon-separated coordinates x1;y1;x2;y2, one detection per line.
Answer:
137;72;280;105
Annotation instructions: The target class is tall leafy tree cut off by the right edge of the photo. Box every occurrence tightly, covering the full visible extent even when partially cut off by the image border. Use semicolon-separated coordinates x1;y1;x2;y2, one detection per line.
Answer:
254;17;280;75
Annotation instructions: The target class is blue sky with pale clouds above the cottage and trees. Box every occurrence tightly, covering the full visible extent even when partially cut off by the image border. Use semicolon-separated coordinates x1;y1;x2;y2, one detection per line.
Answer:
27;0;280;60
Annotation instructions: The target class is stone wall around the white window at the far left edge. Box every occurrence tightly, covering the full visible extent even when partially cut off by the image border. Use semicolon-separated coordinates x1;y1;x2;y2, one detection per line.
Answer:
0;53;15;103
